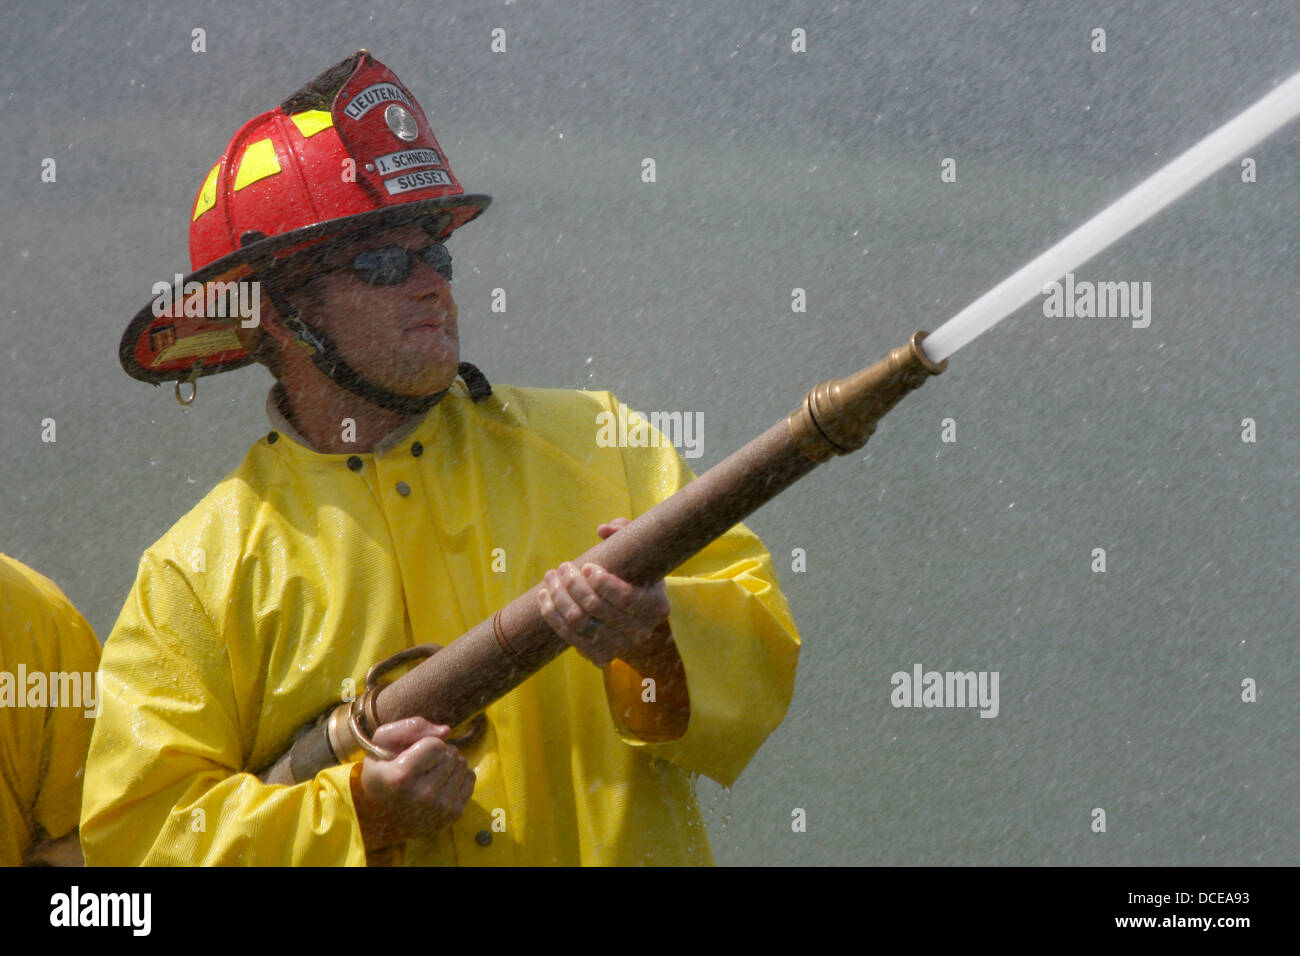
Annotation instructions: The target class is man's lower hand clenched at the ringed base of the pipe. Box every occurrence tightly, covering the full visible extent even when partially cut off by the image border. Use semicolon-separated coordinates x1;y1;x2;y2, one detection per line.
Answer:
352;717;475;852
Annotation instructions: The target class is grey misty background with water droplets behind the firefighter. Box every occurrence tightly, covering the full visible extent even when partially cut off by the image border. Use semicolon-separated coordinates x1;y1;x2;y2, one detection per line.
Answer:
0;0;1300;865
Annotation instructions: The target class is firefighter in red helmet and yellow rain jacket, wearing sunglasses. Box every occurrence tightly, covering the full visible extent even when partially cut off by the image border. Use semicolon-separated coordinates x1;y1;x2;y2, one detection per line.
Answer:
82;51;800;865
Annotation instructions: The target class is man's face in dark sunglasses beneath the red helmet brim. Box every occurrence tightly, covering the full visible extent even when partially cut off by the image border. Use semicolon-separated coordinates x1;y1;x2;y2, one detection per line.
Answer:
290;225;460;395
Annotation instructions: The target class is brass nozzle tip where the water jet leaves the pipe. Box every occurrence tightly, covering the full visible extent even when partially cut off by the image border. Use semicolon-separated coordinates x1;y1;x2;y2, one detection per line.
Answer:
787;332;948;463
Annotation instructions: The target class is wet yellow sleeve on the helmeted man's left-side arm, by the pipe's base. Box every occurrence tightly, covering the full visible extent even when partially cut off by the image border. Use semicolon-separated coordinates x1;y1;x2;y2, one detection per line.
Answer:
81;553;365;866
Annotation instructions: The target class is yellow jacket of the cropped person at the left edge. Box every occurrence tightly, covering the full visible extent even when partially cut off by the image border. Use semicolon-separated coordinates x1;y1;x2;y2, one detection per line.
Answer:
0;554;99;866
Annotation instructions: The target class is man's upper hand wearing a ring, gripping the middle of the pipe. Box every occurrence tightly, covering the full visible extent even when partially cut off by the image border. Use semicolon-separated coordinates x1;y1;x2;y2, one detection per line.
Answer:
537;518;668;667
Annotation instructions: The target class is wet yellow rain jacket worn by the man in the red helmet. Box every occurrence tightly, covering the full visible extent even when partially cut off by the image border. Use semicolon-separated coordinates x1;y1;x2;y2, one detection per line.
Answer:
82;381;800;865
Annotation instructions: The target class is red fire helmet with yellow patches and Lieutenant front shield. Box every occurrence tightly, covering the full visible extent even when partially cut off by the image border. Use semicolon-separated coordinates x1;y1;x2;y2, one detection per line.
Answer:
118;49;491;385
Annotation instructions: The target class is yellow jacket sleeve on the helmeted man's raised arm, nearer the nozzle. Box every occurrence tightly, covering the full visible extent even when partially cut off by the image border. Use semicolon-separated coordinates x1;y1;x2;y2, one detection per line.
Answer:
606;395;800;787
